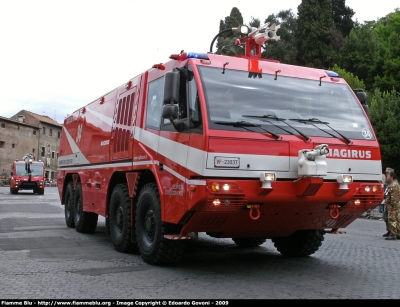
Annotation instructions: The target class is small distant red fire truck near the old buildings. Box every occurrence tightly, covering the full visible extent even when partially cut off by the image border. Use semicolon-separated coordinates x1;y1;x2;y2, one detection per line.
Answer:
10;154;45;195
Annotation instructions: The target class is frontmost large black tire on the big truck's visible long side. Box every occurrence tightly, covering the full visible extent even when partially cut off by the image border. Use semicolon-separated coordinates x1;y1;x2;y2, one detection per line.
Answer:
135;183;185;264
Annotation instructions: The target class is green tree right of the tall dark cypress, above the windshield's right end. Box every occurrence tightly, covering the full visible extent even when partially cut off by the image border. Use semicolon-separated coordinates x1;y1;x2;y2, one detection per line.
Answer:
338;21;377;90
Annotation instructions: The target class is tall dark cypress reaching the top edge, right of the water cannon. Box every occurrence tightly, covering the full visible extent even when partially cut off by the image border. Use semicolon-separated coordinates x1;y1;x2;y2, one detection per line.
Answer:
296;0;335;68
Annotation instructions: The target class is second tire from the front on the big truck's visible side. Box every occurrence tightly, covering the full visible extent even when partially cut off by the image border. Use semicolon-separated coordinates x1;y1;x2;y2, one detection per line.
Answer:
108;184;139;253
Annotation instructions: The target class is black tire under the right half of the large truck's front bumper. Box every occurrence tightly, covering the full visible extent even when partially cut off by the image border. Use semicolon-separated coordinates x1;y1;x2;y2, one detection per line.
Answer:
272;229;325;257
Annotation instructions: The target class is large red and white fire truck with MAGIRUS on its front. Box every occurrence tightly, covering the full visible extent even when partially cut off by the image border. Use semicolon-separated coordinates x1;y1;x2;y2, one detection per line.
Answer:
57;24;383;264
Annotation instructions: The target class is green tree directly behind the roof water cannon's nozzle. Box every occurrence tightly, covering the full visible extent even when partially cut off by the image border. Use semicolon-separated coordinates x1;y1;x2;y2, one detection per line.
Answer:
262;9;297;64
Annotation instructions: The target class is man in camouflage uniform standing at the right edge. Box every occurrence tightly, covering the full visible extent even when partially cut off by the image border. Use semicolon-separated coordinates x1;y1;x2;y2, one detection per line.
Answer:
385;169;400;240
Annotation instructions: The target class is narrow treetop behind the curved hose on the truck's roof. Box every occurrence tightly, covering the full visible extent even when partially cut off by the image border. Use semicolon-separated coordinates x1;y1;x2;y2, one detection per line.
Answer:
217;7;243;55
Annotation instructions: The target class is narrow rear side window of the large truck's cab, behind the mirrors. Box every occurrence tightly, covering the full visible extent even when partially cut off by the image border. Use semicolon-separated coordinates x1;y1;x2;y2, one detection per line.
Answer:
146;77;164;130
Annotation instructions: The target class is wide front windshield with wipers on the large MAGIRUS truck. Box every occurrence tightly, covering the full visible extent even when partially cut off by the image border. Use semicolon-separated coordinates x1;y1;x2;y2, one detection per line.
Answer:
198;66;374;140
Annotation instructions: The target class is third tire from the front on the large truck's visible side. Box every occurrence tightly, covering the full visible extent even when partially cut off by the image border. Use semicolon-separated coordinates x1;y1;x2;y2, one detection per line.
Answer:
74;182;98;233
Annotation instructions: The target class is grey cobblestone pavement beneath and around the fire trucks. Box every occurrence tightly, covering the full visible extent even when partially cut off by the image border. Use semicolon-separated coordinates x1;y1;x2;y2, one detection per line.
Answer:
0;187;400;299
